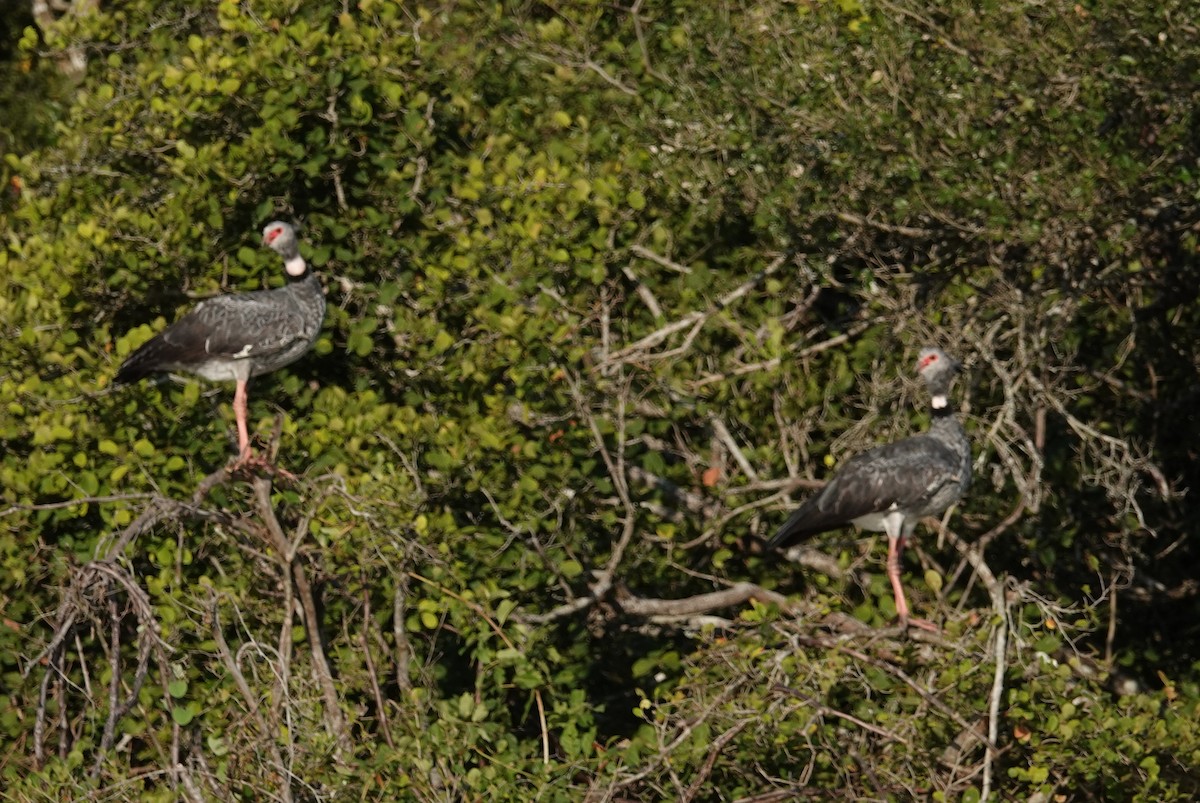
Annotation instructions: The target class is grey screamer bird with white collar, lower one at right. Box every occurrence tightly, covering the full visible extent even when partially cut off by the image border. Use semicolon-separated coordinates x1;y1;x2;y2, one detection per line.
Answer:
768;348;971;630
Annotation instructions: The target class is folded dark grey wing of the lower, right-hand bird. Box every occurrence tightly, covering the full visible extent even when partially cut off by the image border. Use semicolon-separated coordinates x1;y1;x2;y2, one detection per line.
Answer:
768;435;961;549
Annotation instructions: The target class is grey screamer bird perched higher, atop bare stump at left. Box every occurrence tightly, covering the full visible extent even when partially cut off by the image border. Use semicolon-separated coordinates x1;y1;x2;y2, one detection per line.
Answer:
116;221;325;466
